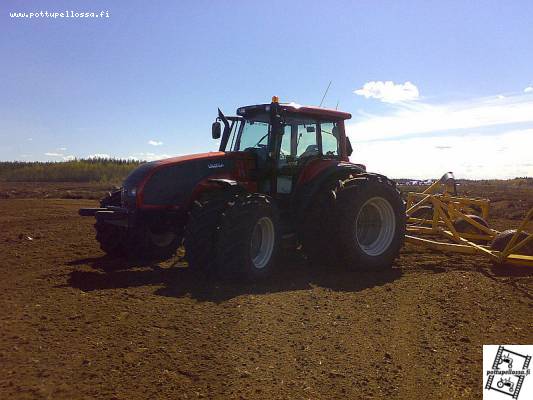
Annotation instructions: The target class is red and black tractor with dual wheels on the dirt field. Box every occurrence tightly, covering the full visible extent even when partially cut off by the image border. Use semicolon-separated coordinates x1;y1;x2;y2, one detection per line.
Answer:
80;97;405;279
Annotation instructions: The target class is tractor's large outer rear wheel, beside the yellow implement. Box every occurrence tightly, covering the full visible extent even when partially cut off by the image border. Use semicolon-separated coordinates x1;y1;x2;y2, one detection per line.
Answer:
334;179;405;270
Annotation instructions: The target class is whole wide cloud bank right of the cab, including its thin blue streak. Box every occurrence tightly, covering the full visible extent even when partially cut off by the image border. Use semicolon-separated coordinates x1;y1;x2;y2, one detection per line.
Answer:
346;94;533;179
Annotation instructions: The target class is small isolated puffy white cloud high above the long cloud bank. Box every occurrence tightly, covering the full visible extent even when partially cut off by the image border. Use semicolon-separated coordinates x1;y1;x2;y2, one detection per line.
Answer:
354;81;420;103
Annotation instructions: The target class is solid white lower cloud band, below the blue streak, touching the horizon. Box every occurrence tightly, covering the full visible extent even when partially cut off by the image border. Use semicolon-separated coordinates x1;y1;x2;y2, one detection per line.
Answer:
350;129;533;179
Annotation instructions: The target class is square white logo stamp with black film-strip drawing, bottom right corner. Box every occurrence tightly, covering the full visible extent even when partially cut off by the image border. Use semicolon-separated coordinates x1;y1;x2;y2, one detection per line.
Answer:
483;345;533;400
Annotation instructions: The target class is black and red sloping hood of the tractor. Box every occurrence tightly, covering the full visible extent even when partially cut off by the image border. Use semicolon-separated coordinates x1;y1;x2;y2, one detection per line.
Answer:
122;152;235;208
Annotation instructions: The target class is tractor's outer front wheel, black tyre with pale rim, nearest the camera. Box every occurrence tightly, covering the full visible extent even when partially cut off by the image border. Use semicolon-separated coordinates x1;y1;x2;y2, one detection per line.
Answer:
215;194;279;280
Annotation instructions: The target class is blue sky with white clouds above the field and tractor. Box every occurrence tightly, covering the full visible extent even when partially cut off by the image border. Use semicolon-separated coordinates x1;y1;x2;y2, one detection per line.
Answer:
0;0;533;179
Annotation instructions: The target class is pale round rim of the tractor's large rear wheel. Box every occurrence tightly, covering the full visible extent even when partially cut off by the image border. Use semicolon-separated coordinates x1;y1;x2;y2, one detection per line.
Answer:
355;197;396;257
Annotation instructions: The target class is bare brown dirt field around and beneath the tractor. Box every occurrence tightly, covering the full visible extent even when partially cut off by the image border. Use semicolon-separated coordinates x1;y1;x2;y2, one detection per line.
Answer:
0;184;533;399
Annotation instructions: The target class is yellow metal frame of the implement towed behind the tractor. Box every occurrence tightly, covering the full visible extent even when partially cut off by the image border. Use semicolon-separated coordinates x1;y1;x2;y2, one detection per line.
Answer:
405;172;533;267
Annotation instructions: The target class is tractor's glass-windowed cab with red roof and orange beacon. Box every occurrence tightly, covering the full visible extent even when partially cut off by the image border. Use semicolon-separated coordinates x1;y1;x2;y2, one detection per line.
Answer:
212;96;352;198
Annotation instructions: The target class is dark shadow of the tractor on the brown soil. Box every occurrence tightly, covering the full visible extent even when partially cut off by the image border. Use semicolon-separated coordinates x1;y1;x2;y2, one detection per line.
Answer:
68;253;402;303
